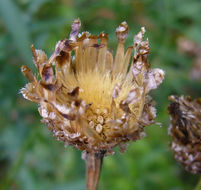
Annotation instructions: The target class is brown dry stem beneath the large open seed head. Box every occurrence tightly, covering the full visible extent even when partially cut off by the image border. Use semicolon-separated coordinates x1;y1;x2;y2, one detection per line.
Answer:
85;151;105;190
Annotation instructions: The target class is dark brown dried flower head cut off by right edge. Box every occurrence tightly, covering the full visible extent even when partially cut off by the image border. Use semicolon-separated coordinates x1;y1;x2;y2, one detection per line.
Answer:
168;96;201;174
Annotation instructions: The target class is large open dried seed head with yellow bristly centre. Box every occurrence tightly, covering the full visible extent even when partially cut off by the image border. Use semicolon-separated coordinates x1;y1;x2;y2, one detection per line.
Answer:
21;19;164;152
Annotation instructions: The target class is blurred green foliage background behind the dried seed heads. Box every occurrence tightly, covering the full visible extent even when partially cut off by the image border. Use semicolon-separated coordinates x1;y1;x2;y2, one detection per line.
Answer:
0;0;201;190
